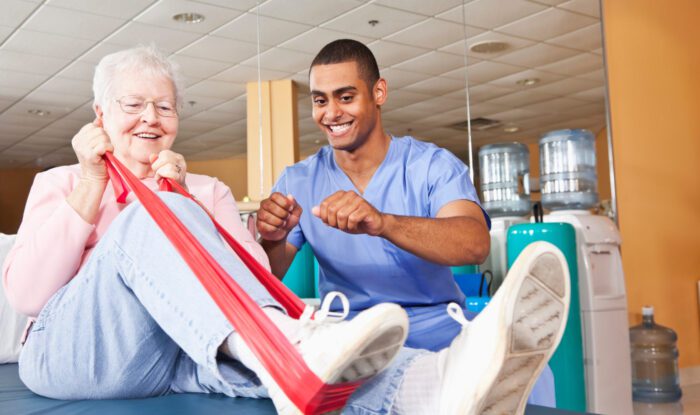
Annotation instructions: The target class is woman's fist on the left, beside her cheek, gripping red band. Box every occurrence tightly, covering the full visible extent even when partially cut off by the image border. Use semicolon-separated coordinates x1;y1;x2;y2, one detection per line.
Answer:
71;118;114;183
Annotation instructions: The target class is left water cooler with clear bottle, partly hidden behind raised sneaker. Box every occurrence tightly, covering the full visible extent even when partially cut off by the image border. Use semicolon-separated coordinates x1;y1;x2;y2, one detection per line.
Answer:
479;142;530;295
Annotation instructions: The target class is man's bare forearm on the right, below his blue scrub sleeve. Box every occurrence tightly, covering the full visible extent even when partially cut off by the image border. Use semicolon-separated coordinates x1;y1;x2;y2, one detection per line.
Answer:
381;214;491;266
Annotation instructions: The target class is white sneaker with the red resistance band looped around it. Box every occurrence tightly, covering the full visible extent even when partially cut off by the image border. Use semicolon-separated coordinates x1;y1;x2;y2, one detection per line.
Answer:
237;292;408;414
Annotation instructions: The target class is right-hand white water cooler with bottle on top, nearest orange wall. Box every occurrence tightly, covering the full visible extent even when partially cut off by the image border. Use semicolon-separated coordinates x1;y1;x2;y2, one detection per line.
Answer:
539;130;632;415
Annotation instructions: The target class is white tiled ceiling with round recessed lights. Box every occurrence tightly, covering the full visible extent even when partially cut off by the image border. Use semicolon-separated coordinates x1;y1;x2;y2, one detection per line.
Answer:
0;0;605;167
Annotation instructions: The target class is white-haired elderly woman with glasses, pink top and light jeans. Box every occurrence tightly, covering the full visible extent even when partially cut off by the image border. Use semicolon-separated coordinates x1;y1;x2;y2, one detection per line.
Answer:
3;47;406;409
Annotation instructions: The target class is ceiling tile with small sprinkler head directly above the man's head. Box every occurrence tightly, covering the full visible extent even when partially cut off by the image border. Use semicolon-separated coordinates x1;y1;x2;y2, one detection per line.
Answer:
321;4;425;39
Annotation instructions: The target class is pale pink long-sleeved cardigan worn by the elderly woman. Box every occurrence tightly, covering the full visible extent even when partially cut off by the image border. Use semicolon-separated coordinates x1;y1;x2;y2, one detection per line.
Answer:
2;164;270;317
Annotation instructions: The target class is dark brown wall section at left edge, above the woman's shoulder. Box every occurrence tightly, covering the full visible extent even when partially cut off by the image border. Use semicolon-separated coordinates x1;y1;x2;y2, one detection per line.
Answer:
0;169;39;234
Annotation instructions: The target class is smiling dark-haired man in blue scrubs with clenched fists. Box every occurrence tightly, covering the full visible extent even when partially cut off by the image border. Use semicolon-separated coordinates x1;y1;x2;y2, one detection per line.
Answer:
257;39;554;406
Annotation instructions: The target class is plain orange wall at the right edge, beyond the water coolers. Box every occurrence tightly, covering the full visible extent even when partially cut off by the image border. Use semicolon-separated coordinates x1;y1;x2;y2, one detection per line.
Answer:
604;0;700;367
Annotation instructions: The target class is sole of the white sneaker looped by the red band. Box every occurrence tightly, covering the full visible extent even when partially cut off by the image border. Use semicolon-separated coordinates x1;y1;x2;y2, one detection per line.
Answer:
320;304;408;384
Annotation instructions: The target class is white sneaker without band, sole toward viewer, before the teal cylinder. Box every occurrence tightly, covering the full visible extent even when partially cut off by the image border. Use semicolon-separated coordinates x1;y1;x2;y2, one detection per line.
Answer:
439;242;570;415
